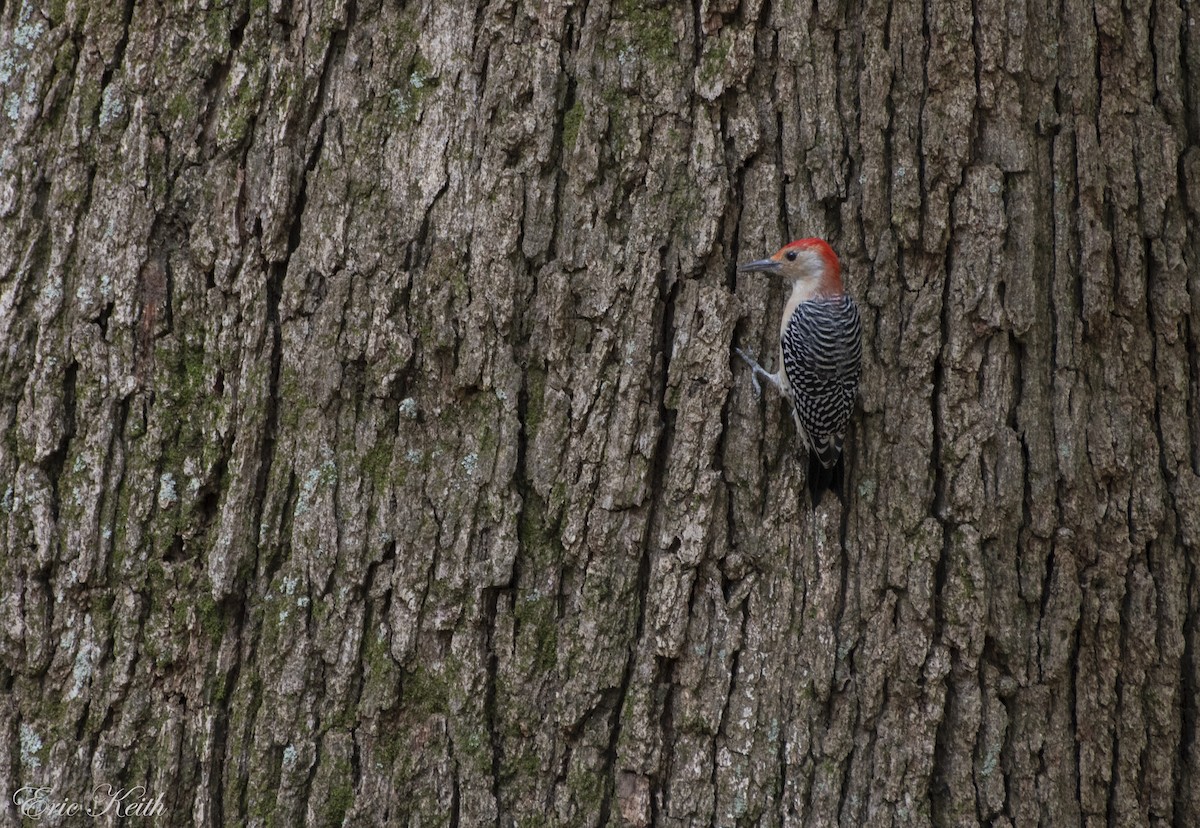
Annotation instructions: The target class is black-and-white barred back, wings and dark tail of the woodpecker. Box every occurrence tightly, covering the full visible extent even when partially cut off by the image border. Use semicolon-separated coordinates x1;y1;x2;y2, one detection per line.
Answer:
780;295;863;503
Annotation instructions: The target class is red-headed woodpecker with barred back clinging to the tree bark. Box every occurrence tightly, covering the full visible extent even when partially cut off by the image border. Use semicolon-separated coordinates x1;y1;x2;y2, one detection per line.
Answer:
734;239;863;509
